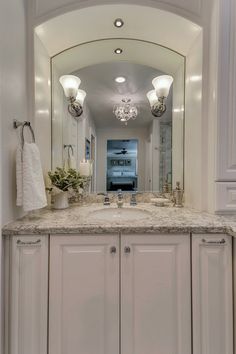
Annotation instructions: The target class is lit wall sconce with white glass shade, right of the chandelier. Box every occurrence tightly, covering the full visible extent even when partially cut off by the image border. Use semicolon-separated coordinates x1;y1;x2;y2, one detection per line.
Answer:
147;75;173;117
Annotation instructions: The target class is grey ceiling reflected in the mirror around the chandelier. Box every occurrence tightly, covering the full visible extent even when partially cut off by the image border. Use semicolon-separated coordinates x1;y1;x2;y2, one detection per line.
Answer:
74;62;172;128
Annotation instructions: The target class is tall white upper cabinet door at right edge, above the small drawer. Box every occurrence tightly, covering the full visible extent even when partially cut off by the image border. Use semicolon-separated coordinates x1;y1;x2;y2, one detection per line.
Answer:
216;0;236;181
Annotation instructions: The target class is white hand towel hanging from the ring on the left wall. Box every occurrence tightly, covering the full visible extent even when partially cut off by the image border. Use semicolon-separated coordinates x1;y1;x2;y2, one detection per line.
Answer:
17;143;47;211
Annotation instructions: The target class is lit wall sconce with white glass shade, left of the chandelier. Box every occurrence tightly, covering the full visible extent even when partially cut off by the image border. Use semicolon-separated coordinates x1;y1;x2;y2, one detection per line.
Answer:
59;75;86;118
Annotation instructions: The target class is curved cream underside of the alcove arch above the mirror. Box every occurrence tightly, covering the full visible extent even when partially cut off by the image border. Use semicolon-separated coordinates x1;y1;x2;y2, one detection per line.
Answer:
35;4;201;56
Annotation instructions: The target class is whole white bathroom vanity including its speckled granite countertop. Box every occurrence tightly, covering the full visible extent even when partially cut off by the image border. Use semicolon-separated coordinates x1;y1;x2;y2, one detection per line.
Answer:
4;203;236;354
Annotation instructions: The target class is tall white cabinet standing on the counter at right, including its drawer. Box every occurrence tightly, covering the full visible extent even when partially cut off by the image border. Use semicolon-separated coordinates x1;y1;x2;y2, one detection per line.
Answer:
213;0;236;213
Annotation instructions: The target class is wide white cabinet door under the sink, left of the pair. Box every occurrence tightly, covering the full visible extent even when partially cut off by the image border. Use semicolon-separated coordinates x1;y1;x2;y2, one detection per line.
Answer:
49;235;119;354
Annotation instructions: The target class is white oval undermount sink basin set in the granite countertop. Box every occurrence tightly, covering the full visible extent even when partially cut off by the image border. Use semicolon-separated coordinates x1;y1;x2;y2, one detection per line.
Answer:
90;207;150;221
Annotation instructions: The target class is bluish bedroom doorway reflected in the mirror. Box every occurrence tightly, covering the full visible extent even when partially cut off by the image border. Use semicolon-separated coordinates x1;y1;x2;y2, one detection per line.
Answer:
107;139;138;191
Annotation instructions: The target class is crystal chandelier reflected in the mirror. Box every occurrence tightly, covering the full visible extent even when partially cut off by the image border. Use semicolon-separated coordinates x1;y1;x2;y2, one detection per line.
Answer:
113;98;138;125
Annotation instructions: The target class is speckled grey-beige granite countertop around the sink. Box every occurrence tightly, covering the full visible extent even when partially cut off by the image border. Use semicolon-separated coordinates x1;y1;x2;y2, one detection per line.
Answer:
3;203;236;236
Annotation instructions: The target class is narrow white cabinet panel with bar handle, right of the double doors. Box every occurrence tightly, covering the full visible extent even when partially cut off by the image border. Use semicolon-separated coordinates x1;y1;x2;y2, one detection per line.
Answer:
192;235;233;354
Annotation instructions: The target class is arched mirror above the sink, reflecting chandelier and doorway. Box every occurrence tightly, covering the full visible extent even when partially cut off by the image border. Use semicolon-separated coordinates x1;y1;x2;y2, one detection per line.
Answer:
52;40;184;192
